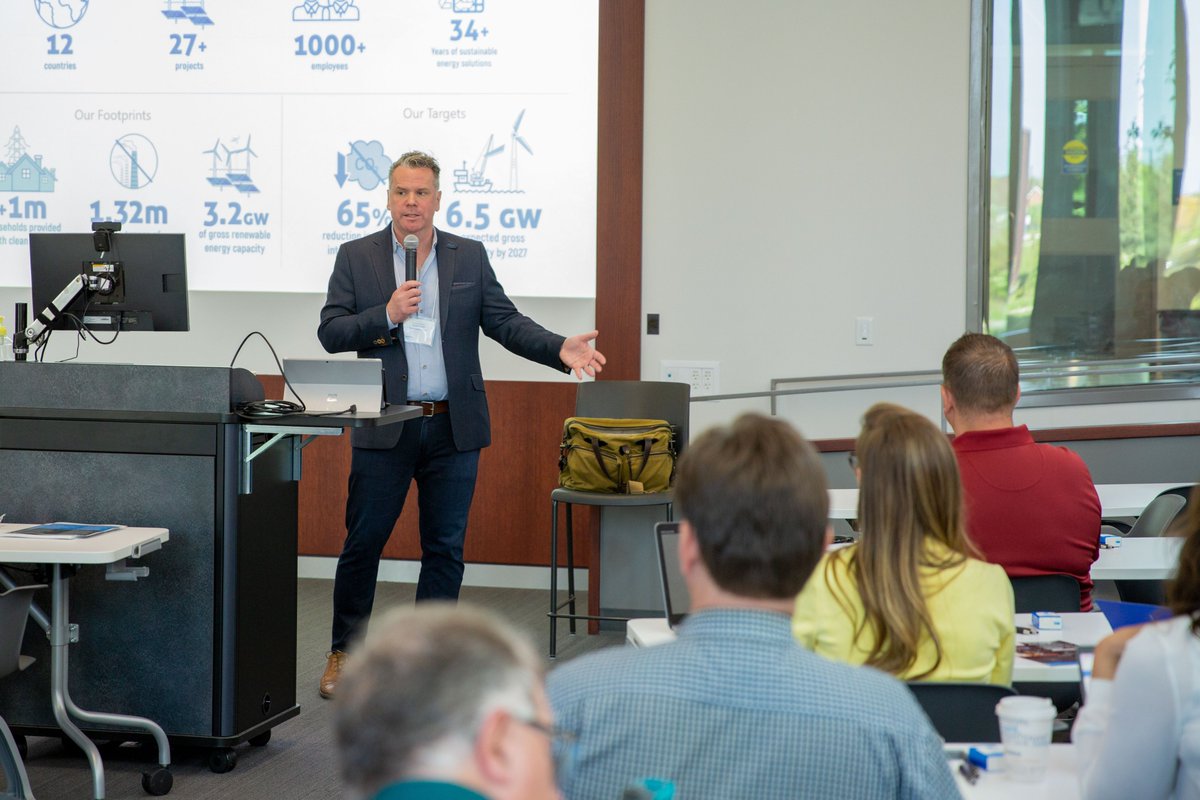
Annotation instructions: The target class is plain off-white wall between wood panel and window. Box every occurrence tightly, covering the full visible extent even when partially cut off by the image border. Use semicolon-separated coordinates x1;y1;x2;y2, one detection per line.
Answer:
642;0;1198;438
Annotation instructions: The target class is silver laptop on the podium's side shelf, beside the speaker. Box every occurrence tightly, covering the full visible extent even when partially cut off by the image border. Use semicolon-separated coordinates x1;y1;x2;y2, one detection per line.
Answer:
283;359;384;414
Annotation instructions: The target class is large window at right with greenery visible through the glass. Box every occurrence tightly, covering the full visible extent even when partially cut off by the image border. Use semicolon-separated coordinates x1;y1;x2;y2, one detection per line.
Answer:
972;0;1200;390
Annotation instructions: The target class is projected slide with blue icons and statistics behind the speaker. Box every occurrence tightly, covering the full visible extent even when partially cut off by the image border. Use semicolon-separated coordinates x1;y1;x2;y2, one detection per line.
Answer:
0;0;598;297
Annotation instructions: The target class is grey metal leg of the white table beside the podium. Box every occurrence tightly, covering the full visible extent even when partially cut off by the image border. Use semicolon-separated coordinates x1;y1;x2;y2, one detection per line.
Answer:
50;564;170;800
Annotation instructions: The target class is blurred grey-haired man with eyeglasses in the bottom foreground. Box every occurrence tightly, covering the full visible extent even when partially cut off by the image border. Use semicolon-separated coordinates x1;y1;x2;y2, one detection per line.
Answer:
334;603;570;800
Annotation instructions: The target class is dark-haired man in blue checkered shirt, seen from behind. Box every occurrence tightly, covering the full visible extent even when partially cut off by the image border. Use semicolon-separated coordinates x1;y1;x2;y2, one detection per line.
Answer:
548;415;959;800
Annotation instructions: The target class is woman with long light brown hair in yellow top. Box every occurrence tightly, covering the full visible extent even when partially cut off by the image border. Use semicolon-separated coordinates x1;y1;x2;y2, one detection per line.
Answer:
792;403;1015;685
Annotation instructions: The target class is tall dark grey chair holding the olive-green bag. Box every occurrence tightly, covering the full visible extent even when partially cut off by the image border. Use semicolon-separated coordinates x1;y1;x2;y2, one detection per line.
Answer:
548;380;691;658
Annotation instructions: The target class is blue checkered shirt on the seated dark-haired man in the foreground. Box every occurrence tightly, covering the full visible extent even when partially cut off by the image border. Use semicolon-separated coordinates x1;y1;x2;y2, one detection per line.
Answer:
547;609;959;800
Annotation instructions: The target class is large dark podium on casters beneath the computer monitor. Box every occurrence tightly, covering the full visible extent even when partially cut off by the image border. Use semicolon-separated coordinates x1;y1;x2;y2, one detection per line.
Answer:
0;362;413;771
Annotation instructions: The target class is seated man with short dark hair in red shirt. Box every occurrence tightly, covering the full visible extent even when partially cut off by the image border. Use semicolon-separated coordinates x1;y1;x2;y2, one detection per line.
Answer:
942;333;1100;610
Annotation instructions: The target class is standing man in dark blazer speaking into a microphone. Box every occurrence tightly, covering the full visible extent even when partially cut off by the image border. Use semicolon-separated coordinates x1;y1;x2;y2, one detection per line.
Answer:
317;151;605;697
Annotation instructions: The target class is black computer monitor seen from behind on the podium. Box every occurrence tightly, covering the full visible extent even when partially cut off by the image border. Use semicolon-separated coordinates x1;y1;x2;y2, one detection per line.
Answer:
29;233;187;331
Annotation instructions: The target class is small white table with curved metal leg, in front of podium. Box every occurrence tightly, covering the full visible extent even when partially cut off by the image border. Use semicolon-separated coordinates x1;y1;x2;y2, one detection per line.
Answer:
0;524;172;800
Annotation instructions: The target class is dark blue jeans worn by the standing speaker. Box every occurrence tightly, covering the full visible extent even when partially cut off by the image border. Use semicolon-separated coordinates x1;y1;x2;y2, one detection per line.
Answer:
332;414;479;650
